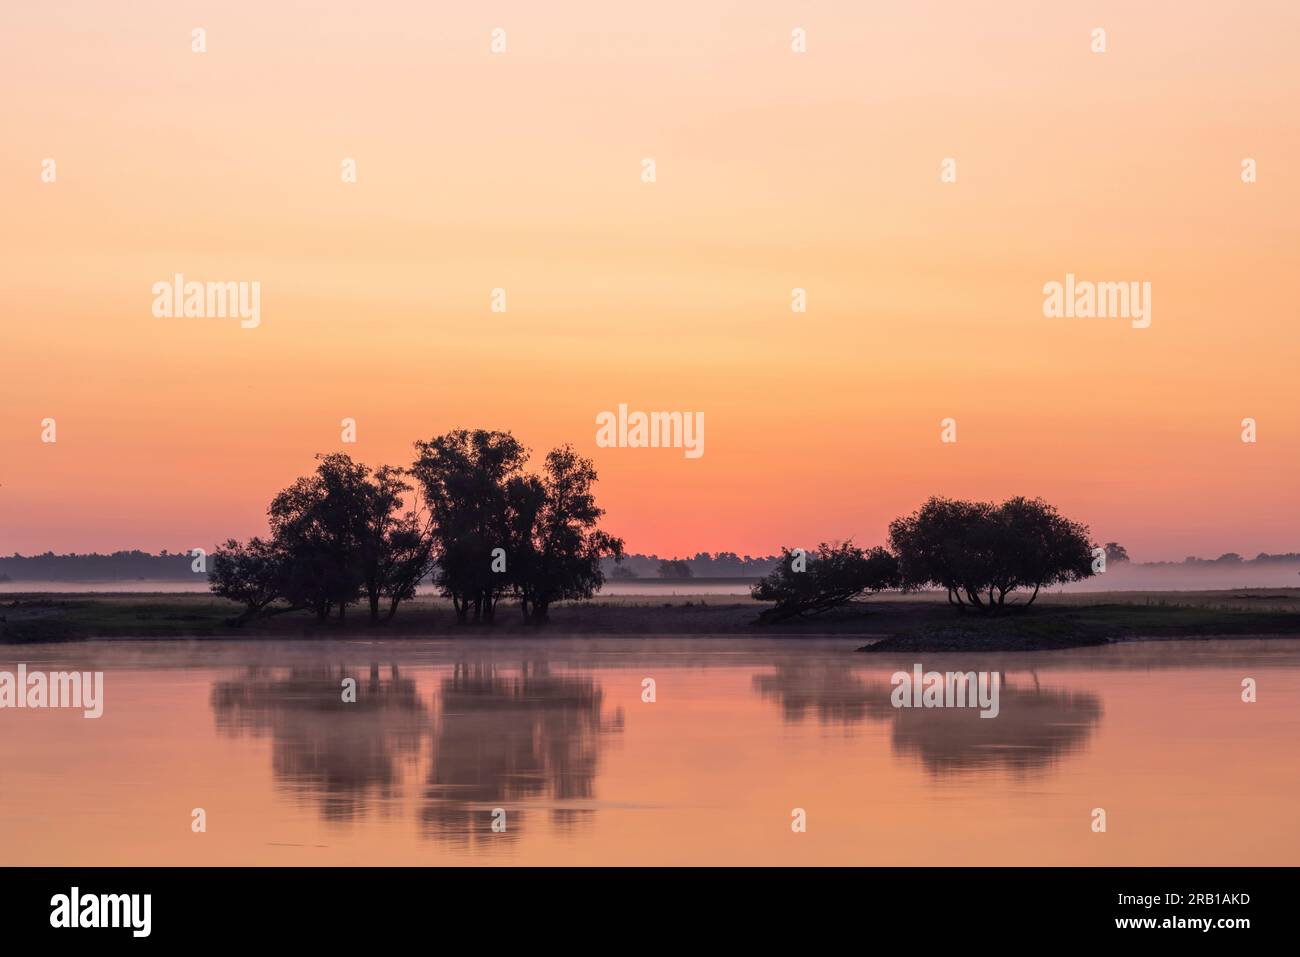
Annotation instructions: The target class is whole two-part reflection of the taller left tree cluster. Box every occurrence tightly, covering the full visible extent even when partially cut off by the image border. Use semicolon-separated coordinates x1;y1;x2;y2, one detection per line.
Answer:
211;662;623;841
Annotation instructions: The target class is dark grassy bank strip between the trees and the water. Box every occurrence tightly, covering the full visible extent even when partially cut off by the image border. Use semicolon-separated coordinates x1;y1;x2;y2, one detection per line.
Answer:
0;589;1300;651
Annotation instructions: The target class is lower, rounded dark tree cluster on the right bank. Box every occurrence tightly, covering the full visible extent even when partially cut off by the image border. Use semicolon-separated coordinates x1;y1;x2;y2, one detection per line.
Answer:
751;498;1093;622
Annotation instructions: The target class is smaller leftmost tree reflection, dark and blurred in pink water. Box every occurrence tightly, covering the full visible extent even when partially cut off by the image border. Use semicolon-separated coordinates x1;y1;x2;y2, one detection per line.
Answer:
211;664;429;820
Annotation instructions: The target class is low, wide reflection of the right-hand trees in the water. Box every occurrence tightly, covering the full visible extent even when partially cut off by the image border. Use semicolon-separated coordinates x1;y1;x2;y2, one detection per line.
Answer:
754;666;1102;774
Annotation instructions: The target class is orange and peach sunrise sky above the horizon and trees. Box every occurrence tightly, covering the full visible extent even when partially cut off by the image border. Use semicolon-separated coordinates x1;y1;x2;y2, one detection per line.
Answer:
0;0;1300;560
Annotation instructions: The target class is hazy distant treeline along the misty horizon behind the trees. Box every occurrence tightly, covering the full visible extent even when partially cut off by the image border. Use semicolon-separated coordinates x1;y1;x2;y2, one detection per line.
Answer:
0;549;1300;584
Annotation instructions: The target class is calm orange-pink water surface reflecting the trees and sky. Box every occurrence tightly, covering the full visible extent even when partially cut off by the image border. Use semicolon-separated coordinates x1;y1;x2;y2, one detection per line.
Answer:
0;638;1300;865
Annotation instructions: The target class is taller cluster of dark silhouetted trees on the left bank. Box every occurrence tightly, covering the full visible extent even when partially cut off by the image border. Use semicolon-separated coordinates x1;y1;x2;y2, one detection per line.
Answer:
211;429;623;623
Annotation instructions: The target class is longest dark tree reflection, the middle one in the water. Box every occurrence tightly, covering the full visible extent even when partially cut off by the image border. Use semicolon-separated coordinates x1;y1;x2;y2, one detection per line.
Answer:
421;662;623;843
